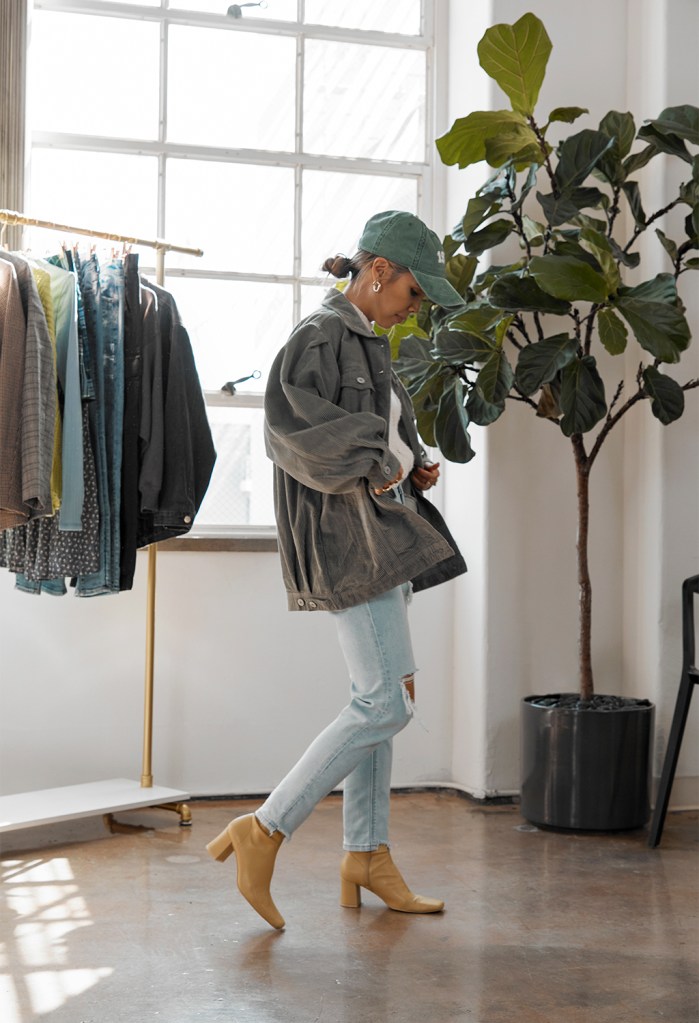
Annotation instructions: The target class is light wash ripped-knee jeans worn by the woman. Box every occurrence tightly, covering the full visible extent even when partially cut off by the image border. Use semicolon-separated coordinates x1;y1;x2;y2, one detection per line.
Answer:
257;583;416;852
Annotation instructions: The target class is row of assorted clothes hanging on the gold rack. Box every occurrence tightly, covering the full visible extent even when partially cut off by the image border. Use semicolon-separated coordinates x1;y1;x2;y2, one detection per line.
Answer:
0;244;216;596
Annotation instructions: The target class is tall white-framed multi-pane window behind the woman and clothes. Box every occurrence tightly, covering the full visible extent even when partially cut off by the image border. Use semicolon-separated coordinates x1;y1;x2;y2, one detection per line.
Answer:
27;0;442;533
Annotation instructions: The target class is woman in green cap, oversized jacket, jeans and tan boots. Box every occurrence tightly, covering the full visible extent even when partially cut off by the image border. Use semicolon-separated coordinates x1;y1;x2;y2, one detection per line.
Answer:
207;211;466;928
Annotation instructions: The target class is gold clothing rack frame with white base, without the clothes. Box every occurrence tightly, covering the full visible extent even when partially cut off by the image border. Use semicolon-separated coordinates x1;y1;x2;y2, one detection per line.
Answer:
0;210;204;832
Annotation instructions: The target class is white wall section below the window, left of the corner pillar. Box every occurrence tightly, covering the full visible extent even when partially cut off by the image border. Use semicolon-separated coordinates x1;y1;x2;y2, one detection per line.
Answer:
0;550;458;795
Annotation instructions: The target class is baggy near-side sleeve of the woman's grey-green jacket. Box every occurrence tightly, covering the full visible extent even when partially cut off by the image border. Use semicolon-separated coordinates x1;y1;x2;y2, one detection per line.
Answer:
265;322;400;493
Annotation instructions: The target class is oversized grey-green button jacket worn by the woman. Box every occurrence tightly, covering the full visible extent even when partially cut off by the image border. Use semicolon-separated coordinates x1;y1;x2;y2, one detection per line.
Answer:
265;290;466;611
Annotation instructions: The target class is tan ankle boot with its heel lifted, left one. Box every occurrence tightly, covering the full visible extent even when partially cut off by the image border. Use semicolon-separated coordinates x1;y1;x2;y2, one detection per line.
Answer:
207;813;285;930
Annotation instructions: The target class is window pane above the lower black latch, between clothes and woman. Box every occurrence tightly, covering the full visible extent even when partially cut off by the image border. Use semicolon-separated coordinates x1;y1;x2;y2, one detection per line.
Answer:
167;277;293;394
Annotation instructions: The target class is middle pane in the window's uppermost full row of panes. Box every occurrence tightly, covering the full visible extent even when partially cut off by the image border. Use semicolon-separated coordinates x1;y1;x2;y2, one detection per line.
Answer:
168;26;296;150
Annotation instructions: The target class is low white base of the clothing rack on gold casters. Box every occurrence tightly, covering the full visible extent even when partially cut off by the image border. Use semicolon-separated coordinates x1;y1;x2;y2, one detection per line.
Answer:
0;777;191;832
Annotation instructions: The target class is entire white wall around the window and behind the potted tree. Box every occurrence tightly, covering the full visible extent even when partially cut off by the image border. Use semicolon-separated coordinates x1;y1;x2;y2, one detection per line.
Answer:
0;0;699;802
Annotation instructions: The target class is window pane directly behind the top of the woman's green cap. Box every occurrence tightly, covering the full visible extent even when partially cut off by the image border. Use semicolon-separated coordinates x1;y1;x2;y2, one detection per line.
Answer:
302;171;418;280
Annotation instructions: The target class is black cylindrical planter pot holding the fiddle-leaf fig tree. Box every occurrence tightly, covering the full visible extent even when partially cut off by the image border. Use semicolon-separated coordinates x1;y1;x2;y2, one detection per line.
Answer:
521;694;655;831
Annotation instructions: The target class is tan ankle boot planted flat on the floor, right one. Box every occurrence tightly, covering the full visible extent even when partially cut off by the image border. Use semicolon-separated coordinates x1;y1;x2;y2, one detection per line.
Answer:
340;845;444;913
